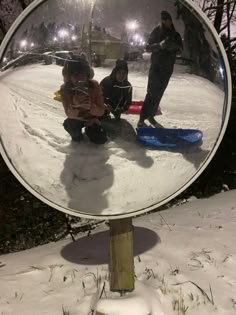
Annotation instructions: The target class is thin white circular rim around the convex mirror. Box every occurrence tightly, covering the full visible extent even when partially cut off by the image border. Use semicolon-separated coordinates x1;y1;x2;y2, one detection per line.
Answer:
0;0;232;220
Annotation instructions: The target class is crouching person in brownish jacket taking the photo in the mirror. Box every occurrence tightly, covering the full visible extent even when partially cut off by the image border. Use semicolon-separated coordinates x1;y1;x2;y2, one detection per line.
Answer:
60;57;107;144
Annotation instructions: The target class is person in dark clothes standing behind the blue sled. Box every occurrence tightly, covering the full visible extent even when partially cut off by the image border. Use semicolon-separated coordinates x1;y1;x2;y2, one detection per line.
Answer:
138;11;183;127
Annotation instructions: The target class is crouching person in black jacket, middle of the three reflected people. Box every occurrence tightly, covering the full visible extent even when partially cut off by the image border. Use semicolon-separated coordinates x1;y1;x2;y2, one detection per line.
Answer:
100;59;132;120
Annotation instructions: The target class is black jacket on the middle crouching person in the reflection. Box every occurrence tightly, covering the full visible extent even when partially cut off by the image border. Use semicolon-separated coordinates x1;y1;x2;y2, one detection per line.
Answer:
100;69;132;112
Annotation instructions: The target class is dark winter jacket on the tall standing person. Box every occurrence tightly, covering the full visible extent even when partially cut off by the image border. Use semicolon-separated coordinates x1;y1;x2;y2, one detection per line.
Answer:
147;25;183;70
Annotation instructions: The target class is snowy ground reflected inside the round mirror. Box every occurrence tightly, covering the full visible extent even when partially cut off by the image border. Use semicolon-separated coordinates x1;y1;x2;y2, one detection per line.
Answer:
0;64;224;215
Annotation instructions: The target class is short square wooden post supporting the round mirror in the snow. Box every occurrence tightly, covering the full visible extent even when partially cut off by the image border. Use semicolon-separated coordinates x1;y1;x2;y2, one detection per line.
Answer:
110;218;134;295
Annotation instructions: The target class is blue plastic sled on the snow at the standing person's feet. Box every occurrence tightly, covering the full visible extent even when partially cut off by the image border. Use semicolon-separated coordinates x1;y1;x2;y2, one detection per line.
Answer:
137;127;203;149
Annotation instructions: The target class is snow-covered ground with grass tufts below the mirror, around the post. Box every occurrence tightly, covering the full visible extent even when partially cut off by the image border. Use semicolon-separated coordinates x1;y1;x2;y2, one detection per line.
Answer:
0;191;236;315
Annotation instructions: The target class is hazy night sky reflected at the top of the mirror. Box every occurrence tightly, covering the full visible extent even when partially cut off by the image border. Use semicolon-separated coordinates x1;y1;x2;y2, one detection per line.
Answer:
8;0;220;54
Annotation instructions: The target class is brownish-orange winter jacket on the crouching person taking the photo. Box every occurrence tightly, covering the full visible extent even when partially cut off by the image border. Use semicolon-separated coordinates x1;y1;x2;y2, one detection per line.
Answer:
61;80;105;121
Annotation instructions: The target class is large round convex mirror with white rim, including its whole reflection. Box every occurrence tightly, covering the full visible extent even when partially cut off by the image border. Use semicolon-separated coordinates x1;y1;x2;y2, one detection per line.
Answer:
0;0;231;219
